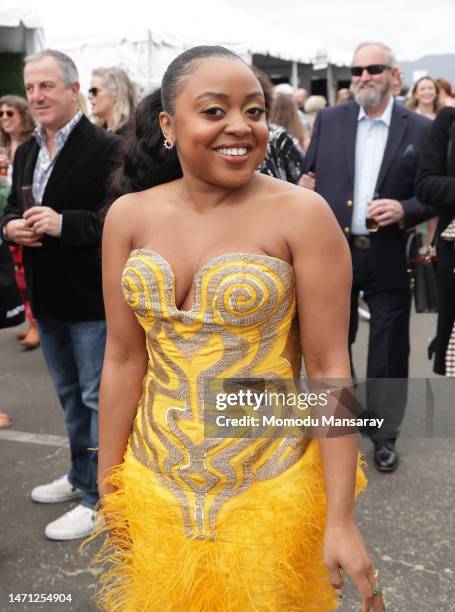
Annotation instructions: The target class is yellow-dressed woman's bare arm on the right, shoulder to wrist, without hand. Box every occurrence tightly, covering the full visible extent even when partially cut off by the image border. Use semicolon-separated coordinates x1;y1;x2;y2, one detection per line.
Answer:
290;192;357;522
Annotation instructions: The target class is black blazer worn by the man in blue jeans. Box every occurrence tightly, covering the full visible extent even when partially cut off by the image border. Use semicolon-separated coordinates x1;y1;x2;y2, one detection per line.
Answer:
0;117;120;321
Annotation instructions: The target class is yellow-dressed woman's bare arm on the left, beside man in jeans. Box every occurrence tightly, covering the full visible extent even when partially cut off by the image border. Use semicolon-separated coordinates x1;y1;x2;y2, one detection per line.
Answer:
98;196;147;497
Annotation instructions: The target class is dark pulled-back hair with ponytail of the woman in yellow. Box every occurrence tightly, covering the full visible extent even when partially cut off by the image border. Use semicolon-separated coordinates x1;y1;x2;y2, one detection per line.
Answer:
108;45;241;204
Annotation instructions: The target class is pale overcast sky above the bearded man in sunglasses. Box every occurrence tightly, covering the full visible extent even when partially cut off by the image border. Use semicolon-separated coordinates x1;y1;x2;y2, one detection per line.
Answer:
227;0;455;60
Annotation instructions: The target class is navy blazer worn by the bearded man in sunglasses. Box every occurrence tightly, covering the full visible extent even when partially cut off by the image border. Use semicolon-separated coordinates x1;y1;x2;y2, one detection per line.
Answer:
304;101;435;289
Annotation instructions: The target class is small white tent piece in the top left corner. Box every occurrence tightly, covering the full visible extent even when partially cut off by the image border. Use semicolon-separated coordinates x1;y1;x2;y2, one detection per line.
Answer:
0;2;44;54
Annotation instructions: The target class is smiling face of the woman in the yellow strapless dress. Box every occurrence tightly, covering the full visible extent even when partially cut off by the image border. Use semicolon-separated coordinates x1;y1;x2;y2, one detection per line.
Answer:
162;58;268;189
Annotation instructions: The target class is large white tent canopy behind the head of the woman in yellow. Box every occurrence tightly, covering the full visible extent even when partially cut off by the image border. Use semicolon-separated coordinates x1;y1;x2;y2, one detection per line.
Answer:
39;0;347;91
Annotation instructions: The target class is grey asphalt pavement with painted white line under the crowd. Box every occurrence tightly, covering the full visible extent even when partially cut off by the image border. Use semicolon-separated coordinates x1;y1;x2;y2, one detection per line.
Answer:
0;315;455;612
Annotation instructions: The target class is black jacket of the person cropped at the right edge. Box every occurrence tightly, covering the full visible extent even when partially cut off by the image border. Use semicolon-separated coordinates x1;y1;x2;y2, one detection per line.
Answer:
416;108;455;374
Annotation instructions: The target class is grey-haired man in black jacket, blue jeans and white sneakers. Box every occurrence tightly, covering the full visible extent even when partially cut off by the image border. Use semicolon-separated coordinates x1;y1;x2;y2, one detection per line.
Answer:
0;50;118;540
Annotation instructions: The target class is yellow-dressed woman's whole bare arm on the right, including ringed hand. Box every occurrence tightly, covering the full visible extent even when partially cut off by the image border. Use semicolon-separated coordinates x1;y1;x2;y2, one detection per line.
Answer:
287;190;383;610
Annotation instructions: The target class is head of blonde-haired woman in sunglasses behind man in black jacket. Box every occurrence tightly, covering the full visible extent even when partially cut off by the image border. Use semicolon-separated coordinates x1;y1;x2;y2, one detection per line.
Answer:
88;66;137;136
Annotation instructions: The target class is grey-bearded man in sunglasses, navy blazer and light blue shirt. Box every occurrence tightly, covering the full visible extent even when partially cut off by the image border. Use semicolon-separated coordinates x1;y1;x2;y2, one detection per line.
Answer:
301;43;434;472
